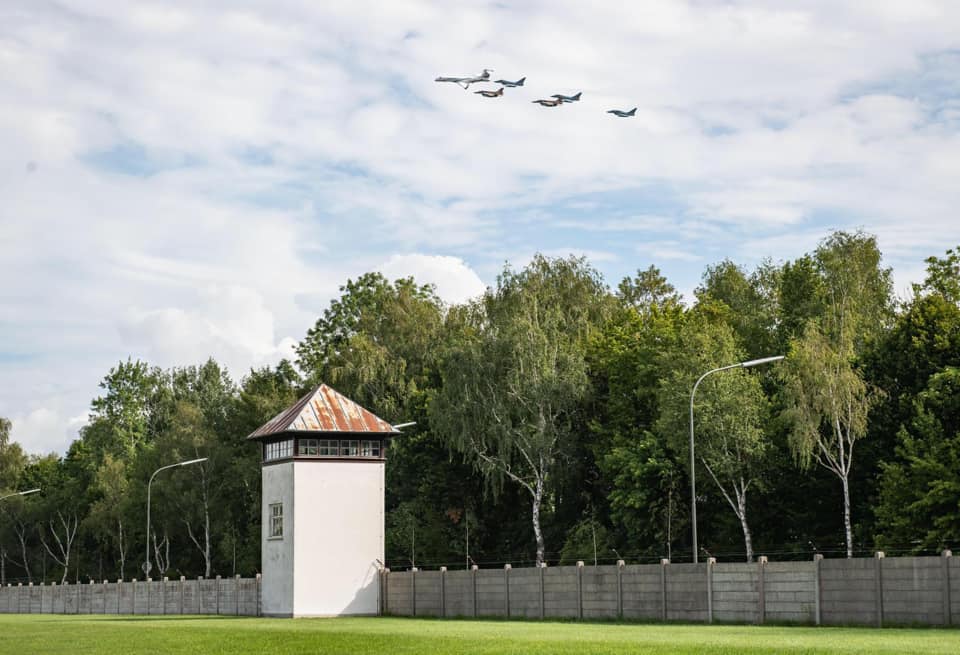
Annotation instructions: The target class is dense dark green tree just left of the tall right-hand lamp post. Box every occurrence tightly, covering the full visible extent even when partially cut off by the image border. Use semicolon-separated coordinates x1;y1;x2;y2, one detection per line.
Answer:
588;282;686;557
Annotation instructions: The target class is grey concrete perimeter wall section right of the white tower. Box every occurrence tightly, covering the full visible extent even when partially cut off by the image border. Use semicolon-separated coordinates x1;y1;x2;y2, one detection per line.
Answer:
384;551;960;626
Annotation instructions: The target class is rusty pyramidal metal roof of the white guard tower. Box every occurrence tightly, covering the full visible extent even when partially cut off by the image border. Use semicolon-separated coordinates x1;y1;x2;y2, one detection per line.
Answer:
247;384;398;439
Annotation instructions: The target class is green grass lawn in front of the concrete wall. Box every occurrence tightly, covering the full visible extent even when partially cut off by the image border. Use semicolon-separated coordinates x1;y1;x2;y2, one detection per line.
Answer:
0;614;960;655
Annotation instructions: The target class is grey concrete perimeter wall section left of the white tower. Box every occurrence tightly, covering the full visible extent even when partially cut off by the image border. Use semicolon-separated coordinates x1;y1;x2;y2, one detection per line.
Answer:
0;576;261;616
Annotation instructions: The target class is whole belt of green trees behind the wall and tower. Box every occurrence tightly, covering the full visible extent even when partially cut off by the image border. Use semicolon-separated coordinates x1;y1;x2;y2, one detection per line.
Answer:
0;232;960;582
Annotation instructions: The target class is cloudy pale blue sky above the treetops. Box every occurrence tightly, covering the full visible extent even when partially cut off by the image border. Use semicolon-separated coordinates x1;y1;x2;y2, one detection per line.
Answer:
0;0;960;453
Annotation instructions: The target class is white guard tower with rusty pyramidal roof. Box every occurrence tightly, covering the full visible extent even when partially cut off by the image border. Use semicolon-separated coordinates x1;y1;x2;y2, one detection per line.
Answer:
247;384;398;617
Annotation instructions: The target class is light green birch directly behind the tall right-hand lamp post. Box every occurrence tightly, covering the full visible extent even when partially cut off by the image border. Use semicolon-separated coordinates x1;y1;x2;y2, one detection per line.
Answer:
657;314;768;562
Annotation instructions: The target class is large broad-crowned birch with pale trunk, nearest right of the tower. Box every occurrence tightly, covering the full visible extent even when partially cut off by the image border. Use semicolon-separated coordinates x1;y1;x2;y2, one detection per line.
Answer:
430;255;606;564
